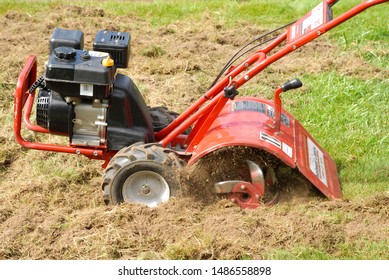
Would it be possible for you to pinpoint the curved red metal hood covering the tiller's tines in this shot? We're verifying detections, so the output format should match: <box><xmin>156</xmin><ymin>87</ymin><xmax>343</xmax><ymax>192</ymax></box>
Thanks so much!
<box><xmin>188</xmin><ymin>97</ymin><xmax>342</xmax><ymax>199</ymax></box>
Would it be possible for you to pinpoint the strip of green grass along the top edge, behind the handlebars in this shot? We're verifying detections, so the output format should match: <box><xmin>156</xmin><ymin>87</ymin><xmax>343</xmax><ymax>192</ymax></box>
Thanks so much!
<box><xmin>0</xmin><ymin>0</ymin><xmax>389</xmax><ymax>65</ymax></box>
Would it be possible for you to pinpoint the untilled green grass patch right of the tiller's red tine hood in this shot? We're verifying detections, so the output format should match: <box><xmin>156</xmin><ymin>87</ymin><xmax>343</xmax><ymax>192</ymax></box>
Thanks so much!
<box><xmin>288</xmin><ymin>72</ymin><xmax>389</xmax><ymax>198</ymax></box>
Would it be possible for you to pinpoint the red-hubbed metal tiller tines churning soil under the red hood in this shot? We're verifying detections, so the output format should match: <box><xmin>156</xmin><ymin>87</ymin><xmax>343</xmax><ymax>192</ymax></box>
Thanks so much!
<box><xmin>214</xmin><ymin>160</ymin><xmax>270</xmax><ymax>208</ymax></box>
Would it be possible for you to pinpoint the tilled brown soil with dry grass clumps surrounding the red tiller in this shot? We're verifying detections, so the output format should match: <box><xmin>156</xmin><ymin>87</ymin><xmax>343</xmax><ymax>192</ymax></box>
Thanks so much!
<box><xmin>0</xmin><ymin>6</ymin><xmax>389</xmax><ymax>259</ymax></box>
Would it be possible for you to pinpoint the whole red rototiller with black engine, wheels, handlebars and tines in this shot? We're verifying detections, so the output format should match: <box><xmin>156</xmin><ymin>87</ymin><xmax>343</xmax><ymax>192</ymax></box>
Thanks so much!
<box><xmin>14</xmin><ymin>0</ymin><xmax>387</xmax><ymax>208</ymax></box>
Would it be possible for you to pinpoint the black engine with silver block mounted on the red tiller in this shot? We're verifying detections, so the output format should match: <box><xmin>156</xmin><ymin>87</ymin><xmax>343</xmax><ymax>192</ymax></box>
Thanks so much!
<box><xmin>36</xmin><ymin>29</ymin><xmax>155</xmax><ymax>151</ymax></box>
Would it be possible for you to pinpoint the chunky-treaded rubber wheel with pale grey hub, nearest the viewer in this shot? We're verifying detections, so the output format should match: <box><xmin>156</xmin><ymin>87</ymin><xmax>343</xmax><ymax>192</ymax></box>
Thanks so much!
<box><xmin>102</xmin><ymin>143</ymin><xmax>181</xmax><ymax>207</ymax></box>
